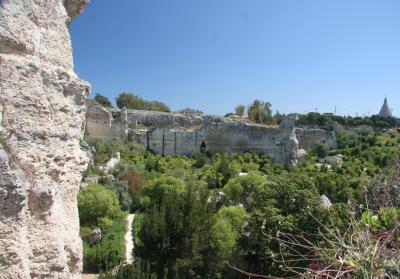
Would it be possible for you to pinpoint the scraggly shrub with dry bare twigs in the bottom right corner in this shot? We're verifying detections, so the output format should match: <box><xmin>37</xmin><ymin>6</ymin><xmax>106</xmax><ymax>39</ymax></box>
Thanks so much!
<box><xmin>278</xmin><ymin>208</ymin><xmax>400</xmax><ymax>278</ymax></box>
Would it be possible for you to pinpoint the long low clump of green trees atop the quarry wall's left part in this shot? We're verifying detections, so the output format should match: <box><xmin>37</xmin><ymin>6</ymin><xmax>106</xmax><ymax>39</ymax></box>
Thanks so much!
<box><xmin>116</xmin><ymin>93</ymin><xmax>171</xmax><ymax>112</ymax></box>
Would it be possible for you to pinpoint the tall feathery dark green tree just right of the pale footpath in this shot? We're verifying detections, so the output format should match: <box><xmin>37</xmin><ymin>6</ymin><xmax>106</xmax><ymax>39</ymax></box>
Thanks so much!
<box><xmin>136</xmin><ymin>178</ymin><xmax>235</xmax><ymax>278</ymax></box>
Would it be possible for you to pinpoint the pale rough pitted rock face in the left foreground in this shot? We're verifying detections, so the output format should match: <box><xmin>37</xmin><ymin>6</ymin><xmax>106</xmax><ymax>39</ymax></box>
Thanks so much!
<box><xmin>0</xmin><ymin>0</ymin><xmax>89</xmax><ymax>279</ymax></box>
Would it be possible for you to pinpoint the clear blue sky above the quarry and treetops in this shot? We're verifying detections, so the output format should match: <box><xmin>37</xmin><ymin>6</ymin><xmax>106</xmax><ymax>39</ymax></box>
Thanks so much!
<box><xmin>71</xmin><ymin>0</ymin><xmax>400</xmax><ymax>116</ymax></box>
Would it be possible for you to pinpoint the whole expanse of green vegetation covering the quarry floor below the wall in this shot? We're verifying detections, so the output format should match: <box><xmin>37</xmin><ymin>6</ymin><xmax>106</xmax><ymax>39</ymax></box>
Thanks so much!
<box><xmin>79</xmin><ymin>127</ymin><xmax>400</xmax><ymax>279</ymax></box>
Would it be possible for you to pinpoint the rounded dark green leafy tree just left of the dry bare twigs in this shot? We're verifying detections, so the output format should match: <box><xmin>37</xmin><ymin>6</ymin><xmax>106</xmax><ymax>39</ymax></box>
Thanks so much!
<box><xmin>237</xmin><ymin>174</ymin><xmax>325</xmax><ymax>275</ymax></box>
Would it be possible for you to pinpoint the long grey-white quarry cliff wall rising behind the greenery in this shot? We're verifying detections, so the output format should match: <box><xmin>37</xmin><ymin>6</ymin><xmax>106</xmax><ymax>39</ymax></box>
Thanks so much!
<box><xmin>86</xmin><ymin>100</ymin><xmax>336</xmax><ymax>166</ymax></box>
